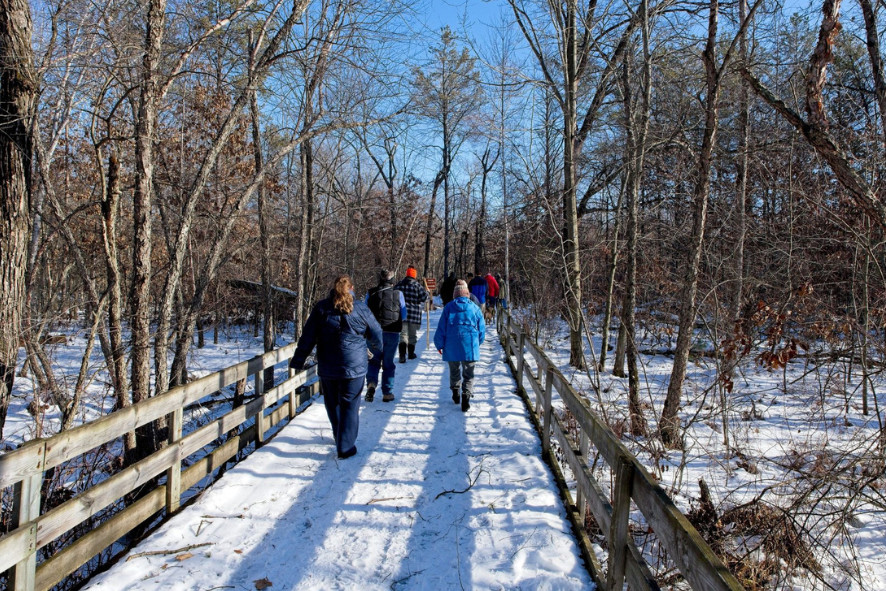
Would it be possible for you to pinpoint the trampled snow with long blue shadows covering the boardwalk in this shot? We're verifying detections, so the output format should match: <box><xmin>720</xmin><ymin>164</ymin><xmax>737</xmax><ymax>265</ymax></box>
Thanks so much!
<box><xmin>86</xmin><ymin>315</ymin><xmax>593</xmax><ymax>591</ymax></box>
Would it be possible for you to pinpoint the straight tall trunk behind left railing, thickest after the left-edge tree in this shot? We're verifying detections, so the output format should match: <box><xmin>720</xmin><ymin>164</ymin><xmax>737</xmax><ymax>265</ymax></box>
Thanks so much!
<box><xmin>128</xmin><ymin>0</ymin><xmax>166</xmax><ymax>462</ymax></box>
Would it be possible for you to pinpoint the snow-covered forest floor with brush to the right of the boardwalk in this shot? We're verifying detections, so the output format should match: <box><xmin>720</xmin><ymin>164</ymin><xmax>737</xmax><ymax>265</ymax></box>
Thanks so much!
<box><xmin>515</xmin><ymin>313</ymin><xmax>886</xmax><ymax>591</ymax></box>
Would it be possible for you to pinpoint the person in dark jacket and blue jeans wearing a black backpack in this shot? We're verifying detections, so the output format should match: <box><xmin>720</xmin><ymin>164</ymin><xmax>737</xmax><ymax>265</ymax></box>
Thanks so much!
<box><xmin>366</xmin><ymin>269</ymin><xmax>408</xmax><ymax>402</ymax></box>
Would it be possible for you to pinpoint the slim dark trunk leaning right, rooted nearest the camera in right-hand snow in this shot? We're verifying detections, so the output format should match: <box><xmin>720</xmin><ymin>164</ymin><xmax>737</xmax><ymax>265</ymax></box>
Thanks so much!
<box><xmin>659</xmin><ymin>0</ymin><xmax>720</xmax><ymax>448</ymax></box>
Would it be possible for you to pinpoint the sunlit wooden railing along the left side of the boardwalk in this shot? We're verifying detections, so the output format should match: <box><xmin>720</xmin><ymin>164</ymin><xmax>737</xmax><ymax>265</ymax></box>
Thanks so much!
<box><xmin>0</xmin><ymin>345</ymin><xmax>318</xmax><ymax>591</ymax></box>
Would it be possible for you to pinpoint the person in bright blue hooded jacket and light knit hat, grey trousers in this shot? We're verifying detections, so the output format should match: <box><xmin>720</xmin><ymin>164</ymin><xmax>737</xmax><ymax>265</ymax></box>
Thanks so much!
<box><xmin>434</xmin><ymin>279</ymin><xmax>486</xmax><ymax>412</ymax></box>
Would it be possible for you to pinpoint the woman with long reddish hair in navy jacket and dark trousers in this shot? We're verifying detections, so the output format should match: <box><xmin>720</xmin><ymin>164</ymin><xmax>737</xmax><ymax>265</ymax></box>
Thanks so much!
<box><xmin>289</xmin><ymin>275</ymin><xmax>382</xmax><ymax>458</ymax></box>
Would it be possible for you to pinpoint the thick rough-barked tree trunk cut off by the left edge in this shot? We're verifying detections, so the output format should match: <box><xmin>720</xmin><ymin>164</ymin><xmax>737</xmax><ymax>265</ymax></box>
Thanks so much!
<box><xmin>0</xmin><ymin>0</ymin><xmax>37</xmax><ymax>438</ymax></box>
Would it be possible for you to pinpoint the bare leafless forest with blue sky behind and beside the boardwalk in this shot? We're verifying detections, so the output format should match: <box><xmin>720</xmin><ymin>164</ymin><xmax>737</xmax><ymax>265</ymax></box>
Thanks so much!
<box><xmin>0</xmin><ymin>0</ymin><xmax>886</xmax><ymax>588</ymax></box>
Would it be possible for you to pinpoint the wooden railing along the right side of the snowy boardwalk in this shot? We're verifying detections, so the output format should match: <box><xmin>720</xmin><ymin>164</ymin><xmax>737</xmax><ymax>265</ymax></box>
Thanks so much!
<box><xmin>497</xmin><ymin>310</ymin><xmax>743</xmax><ymax>591</ymax></box>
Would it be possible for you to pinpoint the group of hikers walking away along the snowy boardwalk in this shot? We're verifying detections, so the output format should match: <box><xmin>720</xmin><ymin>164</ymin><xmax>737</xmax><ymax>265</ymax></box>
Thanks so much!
<box><xmin>289</xmin><ymin>266</ymin><xmax>499</xmax><ymax>459</ymax></box>
